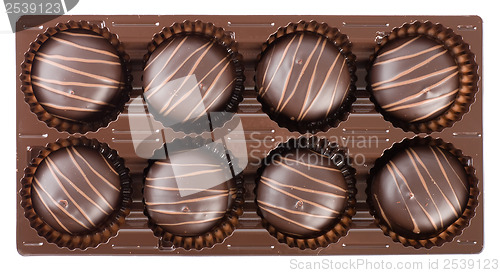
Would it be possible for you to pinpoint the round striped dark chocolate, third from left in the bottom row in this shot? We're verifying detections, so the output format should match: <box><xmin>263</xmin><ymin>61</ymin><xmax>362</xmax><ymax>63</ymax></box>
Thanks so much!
<box><xmin>256</xmin><ymin>148</ymin><xmax>348</xmax><ymax>238</ymax></box>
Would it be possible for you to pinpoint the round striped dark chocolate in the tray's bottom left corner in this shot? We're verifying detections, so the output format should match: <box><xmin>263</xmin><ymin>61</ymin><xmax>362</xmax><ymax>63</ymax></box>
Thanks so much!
<box><xmin>31</xmin><ymin>146</ymin><xmax>122</xmax><ymax>235</ymax></box>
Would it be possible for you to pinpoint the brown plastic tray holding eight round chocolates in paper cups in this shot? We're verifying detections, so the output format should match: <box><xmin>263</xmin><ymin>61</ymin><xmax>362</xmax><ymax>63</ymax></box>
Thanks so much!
<box><xmin>16</xmin><ymin>15</ymin><xmax>483</xmax><ymax>255</ymax></box>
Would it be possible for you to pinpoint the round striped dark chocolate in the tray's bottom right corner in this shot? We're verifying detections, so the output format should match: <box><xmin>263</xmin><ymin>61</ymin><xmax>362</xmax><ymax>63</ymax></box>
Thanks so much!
<box><xmin>368</xmin><ymin>145</ymin><xmax>469</xmax><ymax>239</ymax></box>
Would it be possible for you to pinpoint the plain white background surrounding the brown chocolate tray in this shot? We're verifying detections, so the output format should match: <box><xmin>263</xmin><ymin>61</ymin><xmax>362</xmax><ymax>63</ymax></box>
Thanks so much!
<box><xmin>0</xmin><ymin>0</ymin><xmax>500</xmax><ymax>273</ymax></box>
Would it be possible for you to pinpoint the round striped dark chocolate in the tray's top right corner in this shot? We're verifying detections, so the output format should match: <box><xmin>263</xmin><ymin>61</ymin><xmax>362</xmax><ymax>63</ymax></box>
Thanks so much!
<box><xmin>368</xmin><ymin>35</ymin><xmax>460</xmax><ymax>123</ymax></box>
